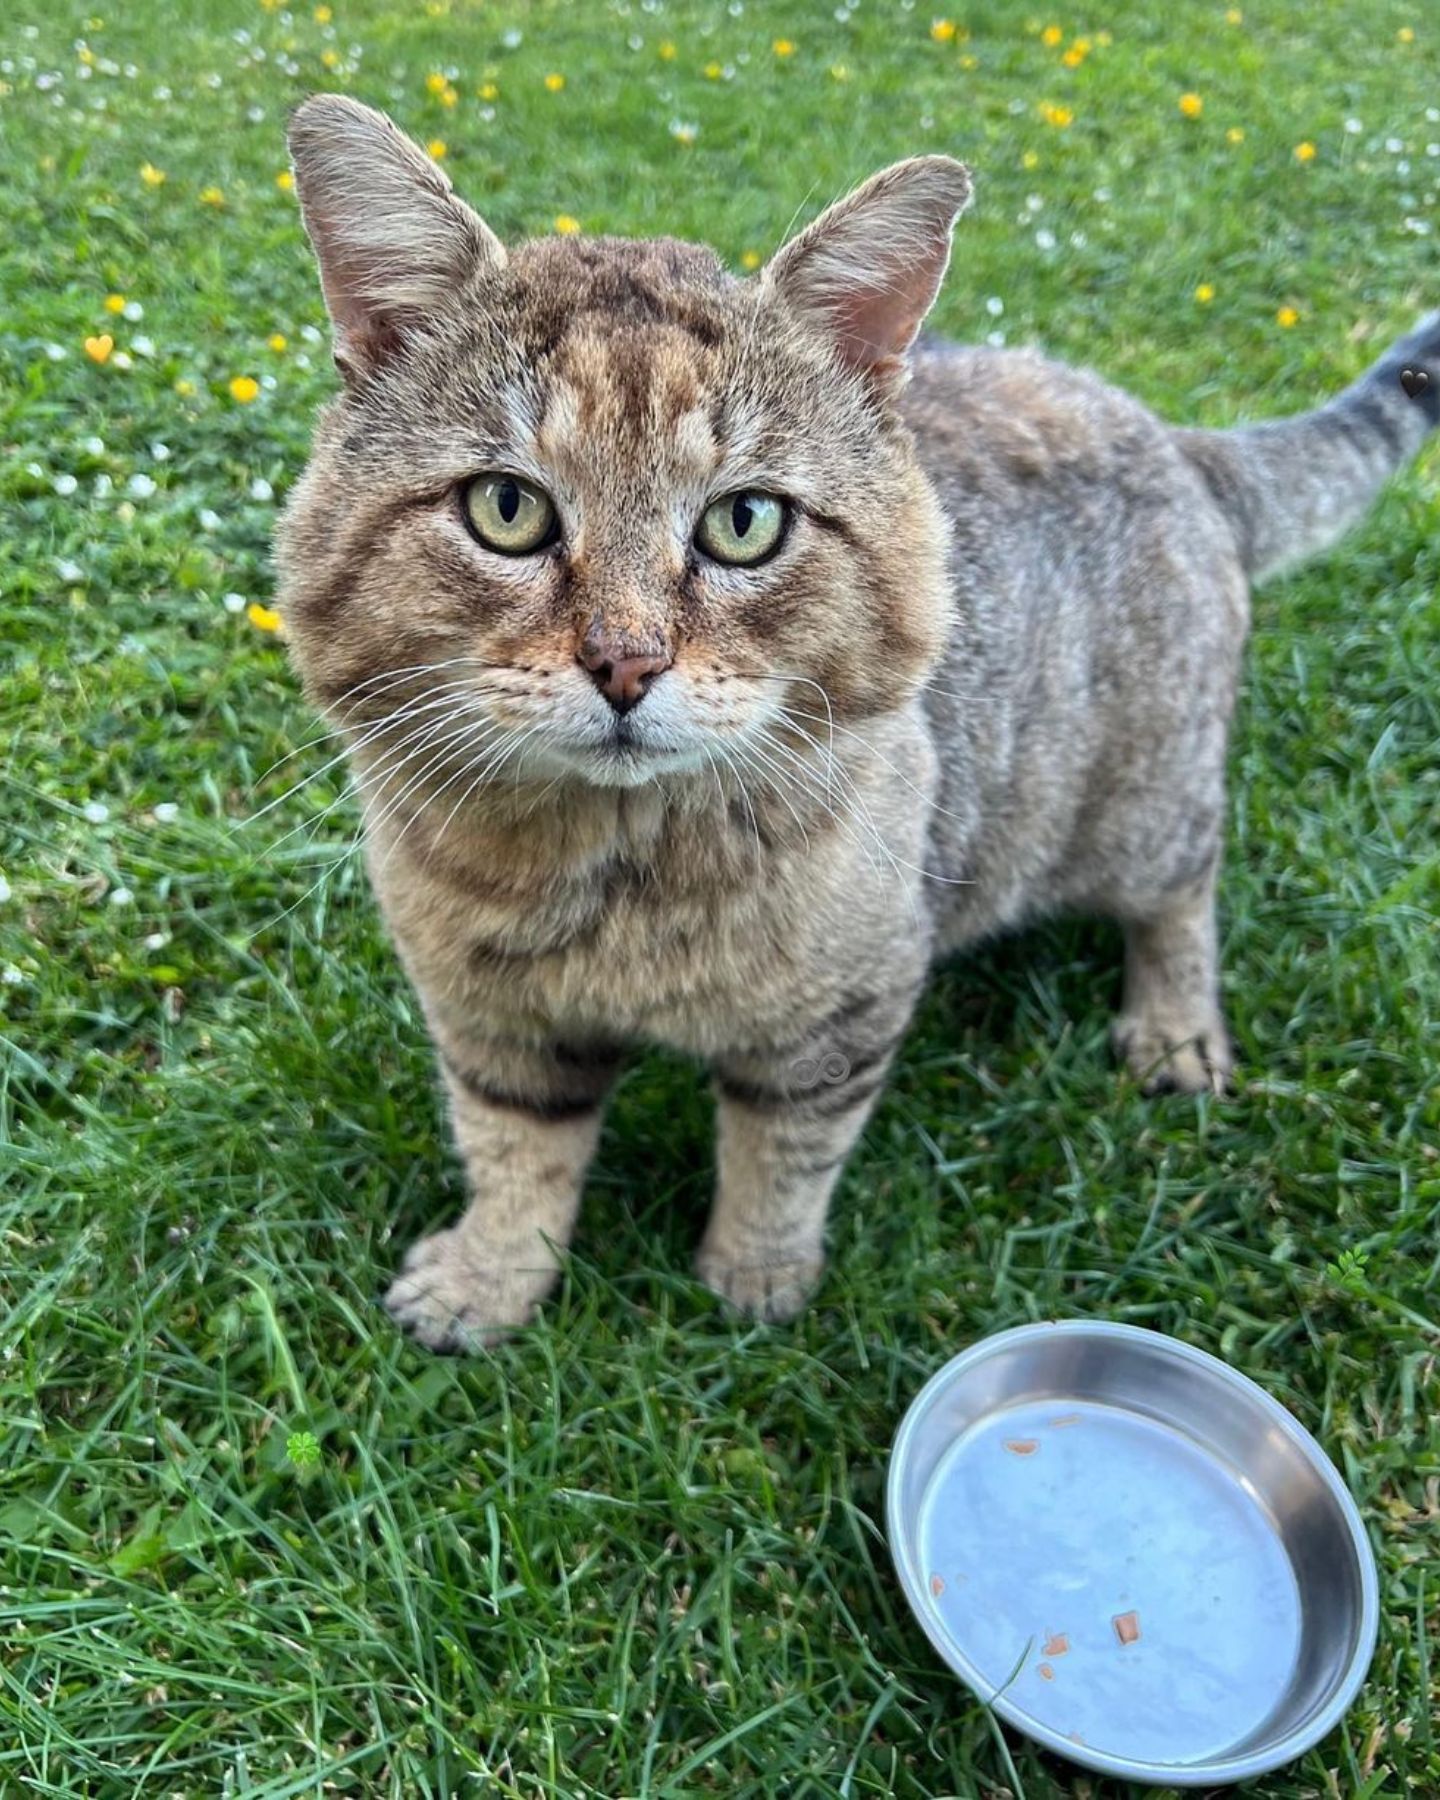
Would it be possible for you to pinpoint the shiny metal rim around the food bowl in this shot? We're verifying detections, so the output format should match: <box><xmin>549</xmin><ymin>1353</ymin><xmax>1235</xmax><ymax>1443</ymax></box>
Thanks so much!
<box><xmin>886</xmin><ymin>1319</ymin><xmax>1381</xmax><ymax>1787</ymax></box>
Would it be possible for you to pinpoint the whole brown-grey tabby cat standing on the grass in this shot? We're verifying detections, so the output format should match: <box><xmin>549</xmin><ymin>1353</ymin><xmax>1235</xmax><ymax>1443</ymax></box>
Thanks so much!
<box><xmin>279</xmin><ymin>95</ymin><xmax>1440</xmax><ymax>1348</ymax></box>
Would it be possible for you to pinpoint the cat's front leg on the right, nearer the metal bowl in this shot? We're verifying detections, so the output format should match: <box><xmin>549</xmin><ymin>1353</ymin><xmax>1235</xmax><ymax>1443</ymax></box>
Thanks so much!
<box><xmin>695</xmin><ymin>995</ymin><xmax>913</xmax><ymax>1321</ymax></box>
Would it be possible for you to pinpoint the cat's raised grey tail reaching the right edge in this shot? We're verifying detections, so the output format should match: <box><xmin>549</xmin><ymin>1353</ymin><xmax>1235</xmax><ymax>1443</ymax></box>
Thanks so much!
<box><xmin>1175</xmin><ymin>311</ymin><xmax>1440</xmax><ymax>580</ymax></box>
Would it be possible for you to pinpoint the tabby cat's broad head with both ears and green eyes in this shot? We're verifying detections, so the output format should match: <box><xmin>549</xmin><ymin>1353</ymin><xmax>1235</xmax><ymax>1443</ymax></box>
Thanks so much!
<box><xmin>279</xmin><ymin>95</ymin><xmax>970</xmax><ymax>787</ymax></box>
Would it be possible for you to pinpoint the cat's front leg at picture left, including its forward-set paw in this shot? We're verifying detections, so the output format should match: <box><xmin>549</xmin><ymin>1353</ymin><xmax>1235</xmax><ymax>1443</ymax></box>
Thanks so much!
<box><xmin>385</xmin><ymin>1033</ymin><xmax>619</xmax><ymax>1350</ymax></box>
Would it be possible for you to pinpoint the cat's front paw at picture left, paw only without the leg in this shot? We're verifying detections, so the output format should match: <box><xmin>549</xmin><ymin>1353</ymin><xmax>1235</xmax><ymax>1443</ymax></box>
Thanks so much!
<box><xmin>385</xmin><ymin>1228</ymin><xmax>556</xmax><ymax>1350</ymax></box>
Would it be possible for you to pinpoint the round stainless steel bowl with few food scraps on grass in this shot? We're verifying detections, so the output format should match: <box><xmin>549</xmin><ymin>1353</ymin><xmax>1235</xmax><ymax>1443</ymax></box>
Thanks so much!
<box><xmin>886</xmin><ymin>1319</ymin><xmax>1379</xmax><ymax>1787</ymax></box>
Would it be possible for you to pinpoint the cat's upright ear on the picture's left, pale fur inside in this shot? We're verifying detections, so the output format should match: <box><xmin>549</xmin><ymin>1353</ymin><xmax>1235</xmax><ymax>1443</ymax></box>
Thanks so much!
<box><xmin>288</xmin><ymin>94</ymin><xmax>506</xmax><ymax>380</ymax></box>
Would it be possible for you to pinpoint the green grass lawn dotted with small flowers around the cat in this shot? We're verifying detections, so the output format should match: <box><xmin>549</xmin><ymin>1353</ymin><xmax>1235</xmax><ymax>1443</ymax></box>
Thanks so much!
<box><xmin>0</xmin><ymin>0</ymin><xmax>1440</xmax><ymax>1800</ymax></box>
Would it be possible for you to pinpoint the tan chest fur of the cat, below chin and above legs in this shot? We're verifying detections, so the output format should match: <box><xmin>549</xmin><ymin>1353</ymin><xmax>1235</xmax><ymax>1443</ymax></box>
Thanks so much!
<box><xmin>358</xmin><ymin>770</ymin><xmax>929</xmax><ymax>1055</ymax></box>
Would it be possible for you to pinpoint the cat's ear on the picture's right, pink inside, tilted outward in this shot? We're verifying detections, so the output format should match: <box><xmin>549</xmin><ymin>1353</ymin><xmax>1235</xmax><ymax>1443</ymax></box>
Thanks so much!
<box><xmin>760</xmin><ymin>157</ymin><xmax>970</xmax><ymax>391</ymax></box>
